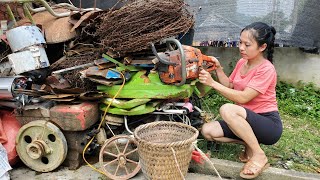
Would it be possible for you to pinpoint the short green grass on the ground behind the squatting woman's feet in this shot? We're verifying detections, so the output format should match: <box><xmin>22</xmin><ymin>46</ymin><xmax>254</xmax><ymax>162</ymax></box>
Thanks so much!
<box><xmin>262</xmin><ymin>113</ymin><xmax>320</xmax><ymax>172</ymax></box>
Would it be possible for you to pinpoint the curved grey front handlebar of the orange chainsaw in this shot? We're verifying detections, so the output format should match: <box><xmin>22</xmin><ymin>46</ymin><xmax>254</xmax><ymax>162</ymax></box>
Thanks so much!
<box><xmin>165</xmin><ymin>39</ymin><xmax>187</xmax><ymax>86</ymax></box>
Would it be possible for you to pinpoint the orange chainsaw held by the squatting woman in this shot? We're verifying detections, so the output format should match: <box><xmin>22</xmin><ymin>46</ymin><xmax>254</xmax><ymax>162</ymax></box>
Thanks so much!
<box><xmin>151</xmin><ymin>39</ymin><xmax>217</xmax><ymax>86</ymax></box>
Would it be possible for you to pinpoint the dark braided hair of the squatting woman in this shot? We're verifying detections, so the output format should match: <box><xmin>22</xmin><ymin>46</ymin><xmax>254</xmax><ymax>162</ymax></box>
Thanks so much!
<box><xmin>241</xmin><ymin>22</ymin><xmax>277</xmax><ymax>63</ymax></box>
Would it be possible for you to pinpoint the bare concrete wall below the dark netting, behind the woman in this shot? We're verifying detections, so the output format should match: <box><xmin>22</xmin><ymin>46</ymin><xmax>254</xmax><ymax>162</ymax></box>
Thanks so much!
<box><xmin>198</xmin><ymin>46</ymin><xmax>320</xmax><ymax>88</ymax></box>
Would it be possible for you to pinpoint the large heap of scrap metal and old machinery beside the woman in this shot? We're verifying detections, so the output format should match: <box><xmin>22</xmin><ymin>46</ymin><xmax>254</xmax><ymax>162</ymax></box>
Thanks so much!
<box><xmin>0</xmin><ymin>0</ymin><xmax>215</xmax><ymax>178</ymax></box>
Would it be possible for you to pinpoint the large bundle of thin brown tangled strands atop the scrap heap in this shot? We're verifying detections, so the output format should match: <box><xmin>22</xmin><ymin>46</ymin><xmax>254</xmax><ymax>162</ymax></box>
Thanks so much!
<box><xmin>85</xmin><ymin>0</ymin><xmax>194</xmax><ymax>56</ymax></box>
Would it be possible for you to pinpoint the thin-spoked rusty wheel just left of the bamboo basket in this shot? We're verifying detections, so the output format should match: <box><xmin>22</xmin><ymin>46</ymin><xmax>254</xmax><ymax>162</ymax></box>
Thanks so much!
<box><xmin>99</xmin><ymin>135</ymin><xmax>141</xmax><ymax>179</ymax></box>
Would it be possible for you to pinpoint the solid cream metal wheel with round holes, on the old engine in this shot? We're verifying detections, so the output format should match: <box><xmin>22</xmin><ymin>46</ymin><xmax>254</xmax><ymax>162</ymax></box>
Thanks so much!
<box><xmin>16</xmin><ymin>120</ymin><xmax>68</xmax><ymax>172</ymax></box>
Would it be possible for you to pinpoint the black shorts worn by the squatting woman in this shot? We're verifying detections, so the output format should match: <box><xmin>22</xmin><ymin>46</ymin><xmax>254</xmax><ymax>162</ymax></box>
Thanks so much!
<box><xmin>218</xmin><ymin>108</ymin><xmax>282</xmax><ymax>145</ymax></box>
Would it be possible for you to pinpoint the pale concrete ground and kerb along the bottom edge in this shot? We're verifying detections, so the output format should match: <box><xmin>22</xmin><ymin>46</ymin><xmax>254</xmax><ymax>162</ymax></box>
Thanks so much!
<box><xmin>10</xmin><ymin>158</ymin><xmax>320</xmax><ymax>180</ymax></box>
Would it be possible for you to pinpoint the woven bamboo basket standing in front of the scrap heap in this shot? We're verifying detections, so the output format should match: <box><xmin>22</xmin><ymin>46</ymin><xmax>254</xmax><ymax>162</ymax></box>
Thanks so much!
<box><xmin>134</xmin><ymin>121</ymin><xmax>199</xmax><ymax>179</ymax></box>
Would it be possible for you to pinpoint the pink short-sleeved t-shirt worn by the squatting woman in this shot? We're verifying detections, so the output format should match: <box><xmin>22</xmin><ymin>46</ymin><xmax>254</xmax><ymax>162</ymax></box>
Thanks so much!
<box><xmin>229</xmin><ymin>58</ymin><xmax>278</xmax><ymax>113</ymax></box>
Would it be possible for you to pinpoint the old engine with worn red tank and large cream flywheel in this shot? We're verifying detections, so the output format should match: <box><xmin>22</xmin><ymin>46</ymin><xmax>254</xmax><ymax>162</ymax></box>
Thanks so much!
<box><xmin>14</xmin><ymin>101</ymin><xmax>100</xmax><ymax>172</ymax></box>
